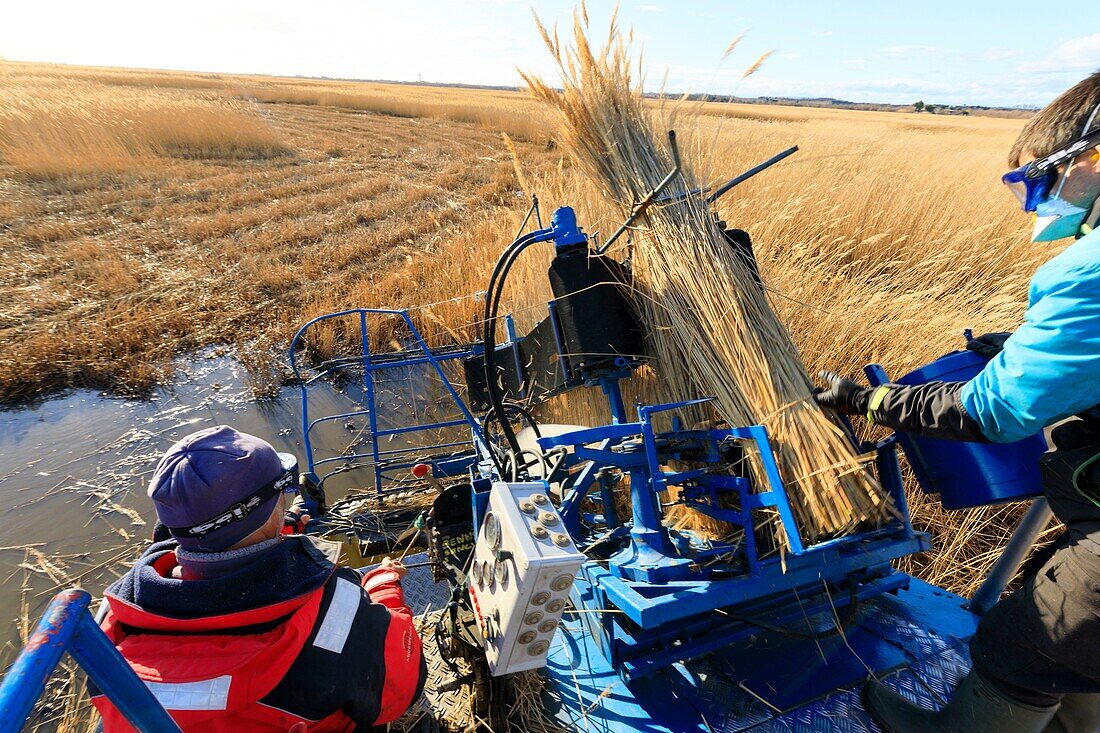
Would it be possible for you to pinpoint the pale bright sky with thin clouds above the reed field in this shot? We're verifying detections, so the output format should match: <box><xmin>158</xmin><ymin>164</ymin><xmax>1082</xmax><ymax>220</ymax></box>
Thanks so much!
<box><xmin>0</xmin><ymin>0</ymin><xmax>1100</xmax><ymax>106</ymax></box>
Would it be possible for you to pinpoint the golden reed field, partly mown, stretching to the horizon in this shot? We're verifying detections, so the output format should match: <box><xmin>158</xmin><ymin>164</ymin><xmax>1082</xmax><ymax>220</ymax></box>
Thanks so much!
<box><xmin>0</xmin><ymin>63</ymin><xmax>1054</xmax><ymax>593</ymax></box>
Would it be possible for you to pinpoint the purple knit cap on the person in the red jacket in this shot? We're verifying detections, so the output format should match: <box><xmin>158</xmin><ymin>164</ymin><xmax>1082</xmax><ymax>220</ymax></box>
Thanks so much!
<box><xmin>149</xmin><ymin>425</ymin><xmax>285</xmax><ymax>553</ymax></box>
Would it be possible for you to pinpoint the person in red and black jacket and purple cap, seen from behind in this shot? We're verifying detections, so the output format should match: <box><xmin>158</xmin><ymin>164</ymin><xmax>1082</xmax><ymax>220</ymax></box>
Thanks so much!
<box><xmin>91</xmin><ymin>426</ymin><xmax>427</xmax><ymax>733</ymax></box>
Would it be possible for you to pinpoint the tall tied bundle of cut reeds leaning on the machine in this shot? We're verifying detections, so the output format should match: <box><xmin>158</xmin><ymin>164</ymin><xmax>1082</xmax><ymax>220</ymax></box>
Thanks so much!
<box><xmin>525</xmin><ymin>6</ymin><xmax>890</xmax><ymax>540</ymax></box>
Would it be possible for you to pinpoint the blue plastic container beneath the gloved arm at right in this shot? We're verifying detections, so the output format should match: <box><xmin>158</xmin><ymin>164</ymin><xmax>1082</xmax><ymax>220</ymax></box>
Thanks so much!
<box><xmin>867</xmin><ymin>351</ymin><xmax>1046</xmax><ymax>510</ymax></box>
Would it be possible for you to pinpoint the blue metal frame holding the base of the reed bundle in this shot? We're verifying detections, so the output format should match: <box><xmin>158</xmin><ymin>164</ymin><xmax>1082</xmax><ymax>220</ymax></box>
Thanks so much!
<box><xmin>539</xmin><ymin>375</ymin><xmax>931</xmax><ymax>680</ymax></box>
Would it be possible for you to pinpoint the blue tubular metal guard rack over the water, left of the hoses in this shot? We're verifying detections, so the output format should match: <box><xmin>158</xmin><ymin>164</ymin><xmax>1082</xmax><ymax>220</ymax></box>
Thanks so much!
<box><xmin>289</xmin><ymin>308</ymin><xmax>486</xmax><ymax>494</ymax></box>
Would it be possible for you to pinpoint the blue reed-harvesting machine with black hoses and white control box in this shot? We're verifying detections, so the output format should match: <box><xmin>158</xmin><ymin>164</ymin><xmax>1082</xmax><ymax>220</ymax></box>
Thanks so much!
<box><xmin>0</xmin><ymin>145</ymin><xmax>1049</xmax><ymax>733</ymax></box>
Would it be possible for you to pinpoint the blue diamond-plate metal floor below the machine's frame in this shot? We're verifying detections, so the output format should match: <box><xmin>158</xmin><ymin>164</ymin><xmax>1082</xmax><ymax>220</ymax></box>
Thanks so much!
<box><xmin>546</xmin><ymin>580</ymin><xmax>977</xmax><ymax>733</ymax></box>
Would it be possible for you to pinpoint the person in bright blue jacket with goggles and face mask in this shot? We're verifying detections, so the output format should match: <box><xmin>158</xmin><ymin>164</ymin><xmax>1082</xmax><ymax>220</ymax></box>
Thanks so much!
<box><xmin>815</xmin><ymin>72</ymin><xmax>1100</xmax><ymax>733</ymax></box>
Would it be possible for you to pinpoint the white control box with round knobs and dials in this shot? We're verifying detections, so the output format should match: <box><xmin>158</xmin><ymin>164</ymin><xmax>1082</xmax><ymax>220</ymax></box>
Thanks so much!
<box><xmin>468</xmin><ymin>481</ymin><xmax>584</xmax><ymax>676</ymax></box>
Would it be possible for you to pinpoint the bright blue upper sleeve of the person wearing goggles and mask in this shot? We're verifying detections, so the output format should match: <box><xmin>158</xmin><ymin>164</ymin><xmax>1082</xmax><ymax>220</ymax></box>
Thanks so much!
<box><xmin>961</xmin><ymin>265</ymin><xmax>1100</xmax><ymax>442</ymax></box>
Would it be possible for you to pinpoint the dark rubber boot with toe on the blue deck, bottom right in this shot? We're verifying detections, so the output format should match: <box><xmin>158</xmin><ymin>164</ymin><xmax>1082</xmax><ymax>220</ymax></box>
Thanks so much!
<box><xmin>864</xmin><ymin>671</ymin><xmax>1057</xmax><ymax>733</ymax></box>
